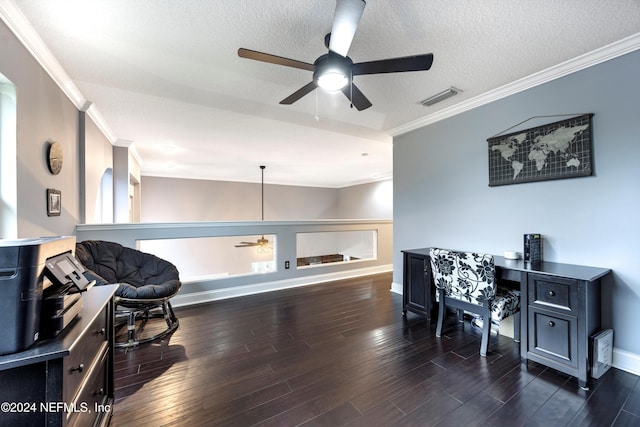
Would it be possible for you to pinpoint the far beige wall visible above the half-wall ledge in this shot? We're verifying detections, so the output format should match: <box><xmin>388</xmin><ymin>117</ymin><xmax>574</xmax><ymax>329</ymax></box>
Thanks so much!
<box><xmin>140</xmin><ymin>176</ymin><xmax>393</xmax><ymax>222</ymax></box>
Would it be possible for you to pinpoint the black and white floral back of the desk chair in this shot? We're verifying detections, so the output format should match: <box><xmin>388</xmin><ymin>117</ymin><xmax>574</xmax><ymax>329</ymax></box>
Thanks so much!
<box><xmin>429</xmin><ymin>248</ymin><xmax>496</xmax><ymax>306</ymax></box>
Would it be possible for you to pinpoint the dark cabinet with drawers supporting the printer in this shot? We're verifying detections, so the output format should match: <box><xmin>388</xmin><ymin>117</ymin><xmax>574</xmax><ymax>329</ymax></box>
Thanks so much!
<box><xmin>0</xmin><ymin>285</ymin><xmax>117</xmax><ymax>426</ymax></box>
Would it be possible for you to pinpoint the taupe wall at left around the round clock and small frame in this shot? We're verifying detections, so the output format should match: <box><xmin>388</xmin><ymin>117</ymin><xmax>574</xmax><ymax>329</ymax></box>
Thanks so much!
<box><xmin>0</xmin><ymin>22</ymin><xmax>79</xmax><ymax>237</ymax></box>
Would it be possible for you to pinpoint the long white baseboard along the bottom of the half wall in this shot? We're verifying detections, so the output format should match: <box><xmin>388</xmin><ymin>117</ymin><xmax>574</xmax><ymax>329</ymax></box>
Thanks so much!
<box><xmin>171</xmin><ymin>264</ymin><xmax>393</xmax><ymax>307</ymax></box>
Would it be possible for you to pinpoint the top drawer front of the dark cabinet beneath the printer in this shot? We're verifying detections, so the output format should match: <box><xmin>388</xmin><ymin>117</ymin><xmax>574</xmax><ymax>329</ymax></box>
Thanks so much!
<box><xmin>62</xmin><ymin>309</ymin><xmax>108</xmax><ymax>402</ymax></box>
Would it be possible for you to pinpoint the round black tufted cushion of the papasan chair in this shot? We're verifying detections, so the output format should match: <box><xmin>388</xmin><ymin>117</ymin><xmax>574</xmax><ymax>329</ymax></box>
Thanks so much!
<box><xmin>76</xmin><ymin>240</ymin><xmax>182</xmax><ymax>299</ymax></box>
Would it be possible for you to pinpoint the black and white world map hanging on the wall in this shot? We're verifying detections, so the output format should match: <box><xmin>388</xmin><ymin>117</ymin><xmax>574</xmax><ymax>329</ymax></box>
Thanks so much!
<box><xmin>487</xmin><ymin>114</ymin><xmax>593</xmax><ymax>187</ymax></box>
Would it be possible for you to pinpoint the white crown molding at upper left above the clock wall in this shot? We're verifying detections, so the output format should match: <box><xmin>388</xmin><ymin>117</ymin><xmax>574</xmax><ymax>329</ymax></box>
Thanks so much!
<box><xmin>0</xmin><ymin>0</ymin><xmax>118</xmax><ymax>144</ymax></box>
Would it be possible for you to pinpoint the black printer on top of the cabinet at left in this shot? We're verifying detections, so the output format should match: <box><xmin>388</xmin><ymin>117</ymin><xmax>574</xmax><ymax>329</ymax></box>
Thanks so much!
<box><xmin>0</xmin><ymin>236</ymin><xmax>94</xmax><ymax>355</ymax></box>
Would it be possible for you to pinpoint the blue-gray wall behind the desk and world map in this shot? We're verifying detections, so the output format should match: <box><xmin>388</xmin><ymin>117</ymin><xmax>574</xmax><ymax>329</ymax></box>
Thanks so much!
<box><xmin>393</xmin><ymin>51</ymin><xmax>640</xmax><ymax>355</ymax></box>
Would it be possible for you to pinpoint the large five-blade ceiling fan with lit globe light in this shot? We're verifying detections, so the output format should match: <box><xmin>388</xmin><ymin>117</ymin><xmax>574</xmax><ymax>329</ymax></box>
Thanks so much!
<box><xmin>238</xmin><ymin>0</ymin><xmax>433</xmax><ymax>111</ymax></box>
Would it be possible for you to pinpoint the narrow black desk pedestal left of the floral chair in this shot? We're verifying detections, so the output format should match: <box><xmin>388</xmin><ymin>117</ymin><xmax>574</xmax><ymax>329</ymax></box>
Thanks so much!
<box><xmin>402</xmin><ymin>249</ymin><xmax>434</xmax><ymax>320</ymax></box>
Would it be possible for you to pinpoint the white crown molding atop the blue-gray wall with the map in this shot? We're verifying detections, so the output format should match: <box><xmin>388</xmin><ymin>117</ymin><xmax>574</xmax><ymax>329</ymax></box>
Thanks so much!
<box><xmin>388</xmin><ymin>33</ymin><xmax>640</xmax><ymax>136</ymax></box>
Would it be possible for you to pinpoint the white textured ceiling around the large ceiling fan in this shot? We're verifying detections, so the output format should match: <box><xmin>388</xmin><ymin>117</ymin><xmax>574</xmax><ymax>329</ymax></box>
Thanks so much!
<box><xmin>0</xmin><ymin>0</ymin><xmax>640</xmax><ymax>187</ymax></box>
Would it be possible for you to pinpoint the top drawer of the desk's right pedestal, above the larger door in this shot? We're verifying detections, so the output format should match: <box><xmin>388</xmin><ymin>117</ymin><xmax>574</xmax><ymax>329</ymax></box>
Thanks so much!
<box><xmin>528</xmin><ymin>274</ymin><xmax>578</xmax><ymax>311</ymax></box>
